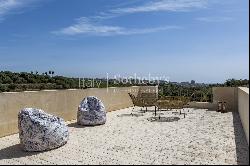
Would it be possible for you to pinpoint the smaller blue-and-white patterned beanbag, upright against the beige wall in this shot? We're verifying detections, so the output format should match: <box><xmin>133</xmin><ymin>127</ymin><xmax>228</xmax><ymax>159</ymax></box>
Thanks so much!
<box><xmin>77</xmin><ymin>96</ymin><xmax>106</xmax><ymax>126</ymax></box>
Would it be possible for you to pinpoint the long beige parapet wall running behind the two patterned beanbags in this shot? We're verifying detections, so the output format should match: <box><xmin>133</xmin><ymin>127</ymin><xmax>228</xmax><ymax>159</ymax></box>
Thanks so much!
<box><xmin>0</xmin><ymin>87</ymin><xmax>139</xmax><ymax>137</ymax></box>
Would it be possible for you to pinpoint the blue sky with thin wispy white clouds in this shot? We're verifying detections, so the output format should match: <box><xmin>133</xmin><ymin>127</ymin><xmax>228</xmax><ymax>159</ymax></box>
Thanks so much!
<box><xmin>0</xmin><ymin>0</ymin><xmax>249</xmax><ymax>83</ymax></box>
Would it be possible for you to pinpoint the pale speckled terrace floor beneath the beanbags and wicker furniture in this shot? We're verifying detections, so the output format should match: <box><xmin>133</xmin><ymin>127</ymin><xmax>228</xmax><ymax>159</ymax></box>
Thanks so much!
<box><xmin>0</xmin><ymin>108</ymin><xmax>249</xmax><ymax>165</ymax></box>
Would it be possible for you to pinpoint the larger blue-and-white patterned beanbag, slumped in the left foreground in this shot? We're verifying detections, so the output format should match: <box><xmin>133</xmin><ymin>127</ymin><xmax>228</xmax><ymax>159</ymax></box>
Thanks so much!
<box><xmin>18</xmin><ymin>108</ymin><xmax>69</xmax><ymax>152</ymax></box>
